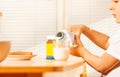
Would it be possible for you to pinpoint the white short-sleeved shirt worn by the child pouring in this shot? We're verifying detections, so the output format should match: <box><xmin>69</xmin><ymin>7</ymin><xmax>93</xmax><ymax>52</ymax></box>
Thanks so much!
<box><xmin>105</xmin><ymin>30</ymin><xmax>120</xmax><ymax>77</ymax></box>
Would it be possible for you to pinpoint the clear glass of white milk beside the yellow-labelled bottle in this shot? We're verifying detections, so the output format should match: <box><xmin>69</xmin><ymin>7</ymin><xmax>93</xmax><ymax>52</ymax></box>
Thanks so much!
<box><xmin>54</xmin><ymin>47</ymin><xmax>69</xmax><ymax>61</ymax></box>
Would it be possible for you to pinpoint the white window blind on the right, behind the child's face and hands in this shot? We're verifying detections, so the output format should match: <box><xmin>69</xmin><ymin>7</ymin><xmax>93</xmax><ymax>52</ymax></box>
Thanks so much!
<box><xmin>67</xmin><ymin>0</ymin><xmax>110</xmax><ymax>25</ymax></box>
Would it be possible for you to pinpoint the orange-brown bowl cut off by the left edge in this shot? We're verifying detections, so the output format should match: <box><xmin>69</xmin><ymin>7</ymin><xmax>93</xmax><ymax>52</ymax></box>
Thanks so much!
<box><xmin>0</xmin><ymin>41</ymin><xmax>11</xmax><ymax>62</ymax></box>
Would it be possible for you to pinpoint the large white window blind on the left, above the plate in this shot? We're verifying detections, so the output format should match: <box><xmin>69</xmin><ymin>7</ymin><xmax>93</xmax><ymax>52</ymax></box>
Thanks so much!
<box><xmin>0</xmin><ymin>0</ymin><xmax>57</xmax><ymax>51</ymax></box>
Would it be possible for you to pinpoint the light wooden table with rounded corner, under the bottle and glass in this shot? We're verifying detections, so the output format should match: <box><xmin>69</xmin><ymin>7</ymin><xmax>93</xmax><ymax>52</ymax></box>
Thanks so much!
<box><xmin>0</xmin><ymin>57</ymin><xmax>84</xmax><ymax>77</ymax></box>
